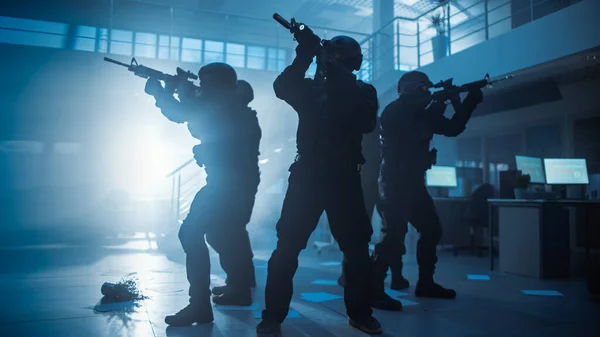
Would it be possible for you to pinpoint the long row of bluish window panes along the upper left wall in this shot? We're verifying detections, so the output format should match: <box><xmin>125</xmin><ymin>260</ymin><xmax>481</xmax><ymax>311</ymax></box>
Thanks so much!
<box><xmin>0</xmin><ymin>16</ymin><xmax>294</xmax><ymax>74</ymax></box>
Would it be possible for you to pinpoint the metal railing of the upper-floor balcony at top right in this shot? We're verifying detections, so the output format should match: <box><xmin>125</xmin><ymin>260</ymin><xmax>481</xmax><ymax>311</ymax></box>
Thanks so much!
<box><xmin>360</xmin><ymin>0</ymin><xmax>582</xmax><ymax>81</ymax></box>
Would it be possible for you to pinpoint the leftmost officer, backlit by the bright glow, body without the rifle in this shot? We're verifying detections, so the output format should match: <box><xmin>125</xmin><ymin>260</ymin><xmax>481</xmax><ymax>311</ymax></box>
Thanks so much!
<box><xmin>146</xmin><ymin>63</ymin><xmax>261</xmax><ymax>326</ymax></box>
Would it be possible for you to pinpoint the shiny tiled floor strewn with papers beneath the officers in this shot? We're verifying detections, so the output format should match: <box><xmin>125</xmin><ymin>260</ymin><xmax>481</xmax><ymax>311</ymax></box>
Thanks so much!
<box><xmin>0</xmin><ymin>236</ymin><xmax>600</xmax><ymax>337</ymax></box>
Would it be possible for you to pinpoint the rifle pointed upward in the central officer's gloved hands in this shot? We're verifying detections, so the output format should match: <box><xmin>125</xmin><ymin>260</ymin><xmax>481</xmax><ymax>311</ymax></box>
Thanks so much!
<box><xmin>273</xmin><ymin>13</ymin><xmax>355</xmax><ymax>81</ymax></box>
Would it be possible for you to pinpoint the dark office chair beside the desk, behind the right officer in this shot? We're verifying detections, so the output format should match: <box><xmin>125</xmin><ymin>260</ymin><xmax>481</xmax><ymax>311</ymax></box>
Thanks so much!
<box><xmin>453</xmin><ymin>184</ymin><xmax>496</xmax><ymax>257</ymax></box>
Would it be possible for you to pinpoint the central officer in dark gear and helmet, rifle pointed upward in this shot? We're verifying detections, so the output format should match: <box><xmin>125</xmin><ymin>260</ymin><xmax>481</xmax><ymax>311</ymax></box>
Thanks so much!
<box><xmin>256</xmin><ymin>14</ymin><xmax>382</xmax><ymax>337</ymax></box>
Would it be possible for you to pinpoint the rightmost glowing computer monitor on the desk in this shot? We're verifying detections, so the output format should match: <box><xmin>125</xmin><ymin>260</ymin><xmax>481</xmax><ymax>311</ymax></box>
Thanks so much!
<box><xmin>544</xmin><ymin>158</ymin><xmax>590</xmax><ymax>185</ymax></box>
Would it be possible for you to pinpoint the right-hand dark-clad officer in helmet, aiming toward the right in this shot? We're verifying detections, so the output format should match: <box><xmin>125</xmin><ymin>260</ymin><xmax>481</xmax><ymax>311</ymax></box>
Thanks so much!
<box><xmin>373</xmin><ymin>71</ymin><xmax>484</xmax><ymax>298</ymax></box>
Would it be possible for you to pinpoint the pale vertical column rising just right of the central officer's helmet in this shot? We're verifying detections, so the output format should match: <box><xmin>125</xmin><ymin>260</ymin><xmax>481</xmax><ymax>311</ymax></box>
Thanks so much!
<box><xmin>370</xmin><ymin>0</ymin><xmax>394</xmax><ymax>80</ymax></box>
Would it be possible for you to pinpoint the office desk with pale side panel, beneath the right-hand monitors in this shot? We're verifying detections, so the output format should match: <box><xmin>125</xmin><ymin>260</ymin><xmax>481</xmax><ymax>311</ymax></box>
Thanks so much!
<box><xmin>488</xmin><ymin>199</ymin><xmax>600</xmax><ymax>278</ymax></box>
